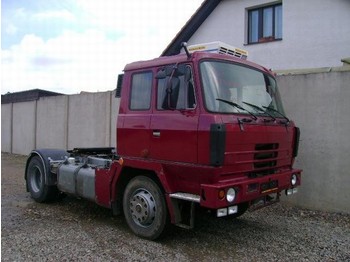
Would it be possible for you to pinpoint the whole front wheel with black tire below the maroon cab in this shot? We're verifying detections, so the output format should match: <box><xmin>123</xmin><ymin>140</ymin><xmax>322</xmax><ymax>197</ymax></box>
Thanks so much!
<box><xmin>123</xmin><ymin>176</ymin><xmax>169</xmax><ymax>240</ymax></box>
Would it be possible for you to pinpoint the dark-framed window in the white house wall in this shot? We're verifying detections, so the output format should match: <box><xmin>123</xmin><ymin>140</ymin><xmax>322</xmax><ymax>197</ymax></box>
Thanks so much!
<box><xmin>248</xmin><ymin>4</ymin><xmax>282</xmax><ymax>44</ymax></box>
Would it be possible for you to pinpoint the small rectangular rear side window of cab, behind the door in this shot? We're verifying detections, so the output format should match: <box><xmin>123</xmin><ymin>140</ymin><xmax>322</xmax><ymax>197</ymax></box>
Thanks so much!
<box><xmin>130</xmin><ymin>72</ymin><xmax>152</xmax><ymax>110</ymax></box>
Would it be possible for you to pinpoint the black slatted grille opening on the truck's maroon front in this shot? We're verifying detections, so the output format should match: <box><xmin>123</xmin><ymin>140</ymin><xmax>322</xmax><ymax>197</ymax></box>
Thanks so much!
<box><xmin>254</xmin><ymin>143</ymin><xmax>278</xmax><ymax>169</ymax></box>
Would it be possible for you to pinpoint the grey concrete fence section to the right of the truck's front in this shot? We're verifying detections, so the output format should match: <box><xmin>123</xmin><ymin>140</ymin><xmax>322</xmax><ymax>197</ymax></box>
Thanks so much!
<box><xmin>278</xmin><ymin>71</ymin><xmax>350</xmax><ymax>213</ymax></box>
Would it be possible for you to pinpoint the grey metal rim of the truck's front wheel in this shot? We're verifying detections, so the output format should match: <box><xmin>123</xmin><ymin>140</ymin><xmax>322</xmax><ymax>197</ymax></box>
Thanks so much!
<box><xmin>130</xmin><ymin>189</ymin><xmax>156</xmax><ymax>227</ymax></box>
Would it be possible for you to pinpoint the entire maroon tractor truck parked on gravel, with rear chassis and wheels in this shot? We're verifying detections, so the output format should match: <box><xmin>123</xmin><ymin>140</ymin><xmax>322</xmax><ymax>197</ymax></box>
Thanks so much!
<box><xmin>25</xmin><ymin>43</ymin><xmax>301</xmax><ymax>240</ymax></box>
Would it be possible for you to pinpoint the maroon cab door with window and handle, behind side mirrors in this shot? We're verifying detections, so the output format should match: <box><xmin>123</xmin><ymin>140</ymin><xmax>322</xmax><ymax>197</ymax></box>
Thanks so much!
<box><xmin>150</xmin><ymin>64</ymin><xmax>198</xmax><ymax>163</ymax></box>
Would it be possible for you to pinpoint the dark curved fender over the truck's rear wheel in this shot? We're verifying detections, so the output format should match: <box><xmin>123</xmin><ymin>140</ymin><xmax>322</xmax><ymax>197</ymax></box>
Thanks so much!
<box><xmin>24</xmin><ymin>149</ymin><xmax>70</xmax><ymax>191</ymax></box>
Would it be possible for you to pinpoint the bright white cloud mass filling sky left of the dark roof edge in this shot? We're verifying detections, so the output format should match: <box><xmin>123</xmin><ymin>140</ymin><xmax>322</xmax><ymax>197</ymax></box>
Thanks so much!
<box><xmin>1</xmin><ymin>0</ymin><xmax>202</xmax><ymax>94</ymax></box>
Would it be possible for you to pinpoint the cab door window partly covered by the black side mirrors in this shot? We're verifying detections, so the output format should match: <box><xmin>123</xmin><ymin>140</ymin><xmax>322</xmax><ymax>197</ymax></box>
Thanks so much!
<box><xmin>157</xmin><ymin>66</ymin><xmax>196</xmax><ymax>110</ymax></box>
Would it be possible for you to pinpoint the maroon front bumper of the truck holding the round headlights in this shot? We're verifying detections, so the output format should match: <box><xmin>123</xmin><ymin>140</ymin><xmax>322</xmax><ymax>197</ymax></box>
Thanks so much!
<box><xmin>200</xmin><ymin>169</ymin><xmax>301</xmax><ymax>209</ymax></box>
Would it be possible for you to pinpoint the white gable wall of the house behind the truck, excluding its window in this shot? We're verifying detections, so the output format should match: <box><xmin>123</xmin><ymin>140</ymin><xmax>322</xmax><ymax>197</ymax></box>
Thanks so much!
<box><xmin>188</xmin><ymin>0</ymin><xmax>350</xmax><ymax>70</ymax></box>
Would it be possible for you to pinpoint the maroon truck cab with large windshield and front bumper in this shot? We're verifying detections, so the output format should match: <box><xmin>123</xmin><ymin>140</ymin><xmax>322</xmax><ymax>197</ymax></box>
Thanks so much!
<box><xmin>117</xmin><ymin>42</ymin><xmax>300</xmax><ymax>206</ymax></box>
